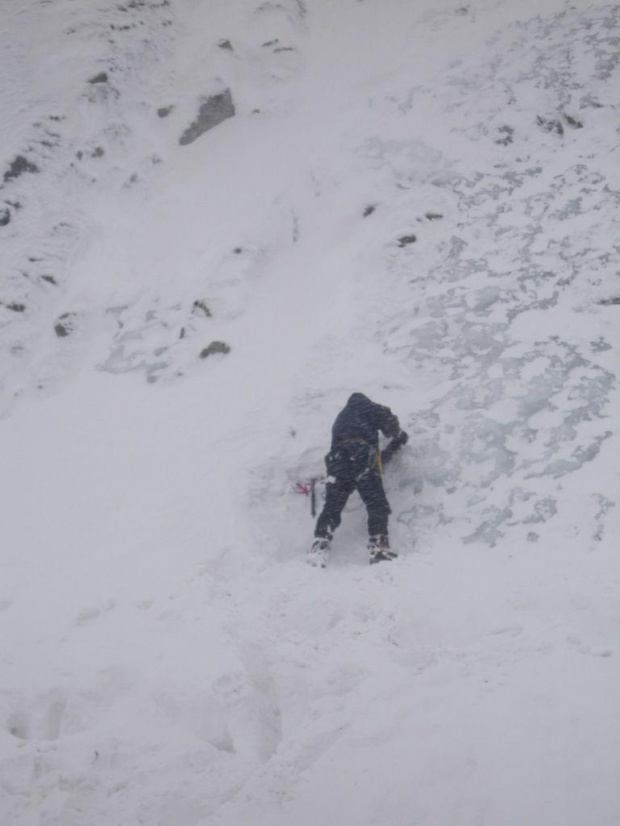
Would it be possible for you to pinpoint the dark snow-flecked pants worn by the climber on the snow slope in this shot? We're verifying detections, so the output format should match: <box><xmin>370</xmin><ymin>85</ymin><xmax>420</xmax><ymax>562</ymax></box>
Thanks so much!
<box><xmin>314</xmin><ymin>441</ymin><xmax>391</xmax><ymax>539</ymax></box>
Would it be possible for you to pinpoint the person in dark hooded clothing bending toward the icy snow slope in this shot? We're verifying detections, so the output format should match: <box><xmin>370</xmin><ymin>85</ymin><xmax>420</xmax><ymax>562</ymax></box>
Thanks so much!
<box><xmin>308</xmin><ymin>393</ymin><xmax>409</xmax><ymax>568</ymax></box>
